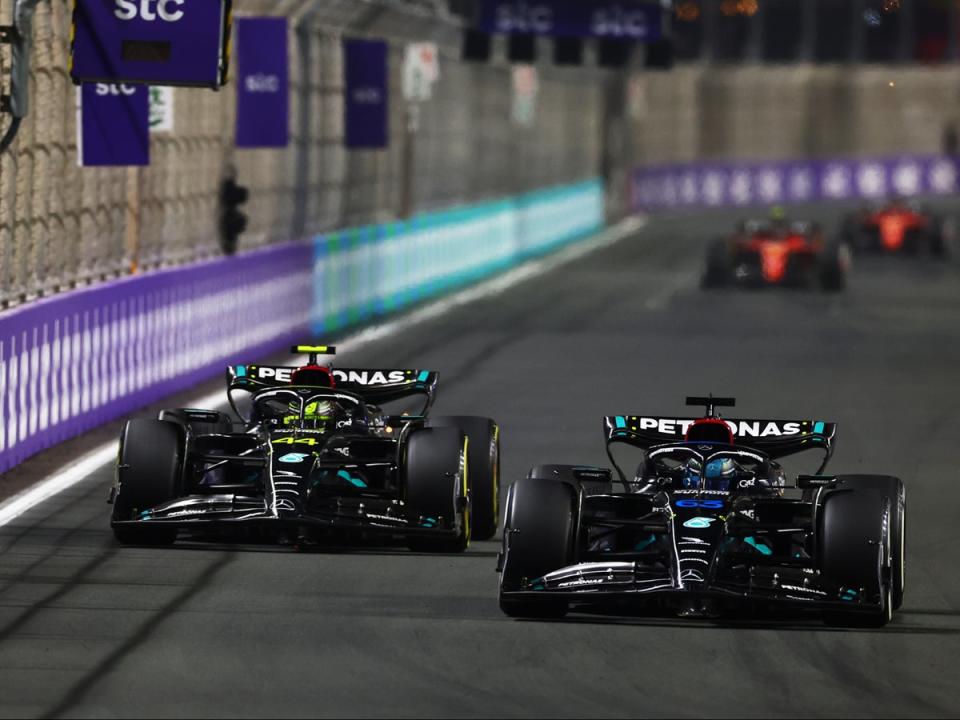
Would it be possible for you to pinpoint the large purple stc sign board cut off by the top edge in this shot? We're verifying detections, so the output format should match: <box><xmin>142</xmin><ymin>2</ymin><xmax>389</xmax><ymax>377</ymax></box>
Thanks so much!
<box><xmin>70</xmin><ymin>0</ymin><xmax>230</xmax><ymax>87</ymax></box>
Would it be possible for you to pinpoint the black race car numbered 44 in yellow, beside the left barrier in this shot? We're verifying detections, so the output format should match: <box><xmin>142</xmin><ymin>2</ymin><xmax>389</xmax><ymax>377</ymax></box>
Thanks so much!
<box><xmin>111</xmin><ymin>346</ymin><xmax>500</xmax><ymax>552</ymax></box>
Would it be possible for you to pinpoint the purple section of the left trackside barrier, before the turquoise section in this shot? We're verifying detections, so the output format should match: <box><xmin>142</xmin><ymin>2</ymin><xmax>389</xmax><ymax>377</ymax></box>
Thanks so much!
<box><xmin>0</xmin><ymin>242</ymin><xmax>313</xmax><ymax>472</ymax></box>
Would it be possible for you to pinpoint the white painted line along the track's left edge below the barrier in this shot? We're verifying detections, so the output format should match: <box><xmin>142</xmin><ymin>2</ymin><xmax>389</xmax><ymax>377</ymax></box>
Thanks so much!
<box><xmin>0</xmin><ymin>217</ymin><xmax>646</xmax><ymax>527</ymax></box>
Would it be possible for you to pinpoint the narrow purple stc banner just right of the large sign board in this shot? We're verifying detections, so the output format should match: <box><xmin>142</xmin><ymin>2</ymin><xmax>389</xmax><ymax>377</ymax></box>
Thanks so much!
<box><xmin>237</xmin><ymin>18</ymin><xmax>290</xmax><ymax>148</ymax></box>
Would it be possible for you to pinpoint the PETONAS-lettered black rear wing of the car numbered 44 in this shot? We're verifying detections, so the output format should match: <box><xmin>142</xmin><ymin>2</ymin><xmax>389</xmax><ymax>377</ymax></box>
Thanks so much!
<box><xmin>227</xmin><ymin>365</ymin><xmax>440</xmax><ymax>414</ymax></box>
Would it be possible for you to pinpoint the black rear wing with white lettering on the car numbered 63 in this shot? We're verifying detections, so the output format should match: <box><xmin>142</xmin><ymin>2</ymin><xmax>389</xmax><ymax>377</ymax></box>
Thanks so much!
<box><xmin>604</xmin><ymin>415</ymin><xmax>837</xmax><ymax>474</ymax></box>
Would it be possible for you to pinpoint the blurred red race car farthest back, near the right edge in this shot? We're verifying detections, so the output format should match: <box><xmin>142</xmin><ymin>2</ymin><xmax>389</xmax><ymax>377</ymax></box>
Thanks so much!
<box><xmin>843</xmin><ymin>199</ymin><xmax>947</xmax><ymax>257</ymax></box>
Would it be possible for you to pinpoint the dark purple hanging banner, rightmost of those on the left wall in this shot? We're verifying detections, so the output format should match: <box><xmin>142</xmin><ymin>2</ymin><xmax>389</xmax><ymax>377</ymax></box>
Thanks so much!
<box><xmin>343</xmin><ymin>39</ymin><xmax>390</xmax><ymax>150</ymax></box>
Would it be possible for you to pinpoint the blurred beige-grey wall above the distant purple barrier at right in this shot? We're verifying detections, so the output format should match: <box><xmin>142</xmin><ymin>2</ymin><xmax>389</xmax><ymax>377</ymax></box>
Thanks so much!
<box><xmin>631</xmin><ymin>65</ymin><xmax>960</xmax><ymax>165</ymax></box>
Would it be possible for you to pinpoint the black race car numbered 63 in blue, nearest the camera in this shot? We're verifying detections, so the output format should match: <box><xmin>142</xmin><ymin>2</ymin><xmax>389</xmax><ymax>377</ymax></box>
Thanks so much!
<box><xmin>499</xmin><ymin>398</ymin><xmax>905</xmax><ymax>626</ymax></box>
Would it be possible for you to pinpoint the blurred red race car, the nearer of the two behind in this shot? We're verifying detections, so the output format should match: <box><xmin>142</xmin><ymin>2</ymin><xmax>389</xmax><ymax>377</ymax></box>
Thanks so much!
<box><xmin>701</xmin><ymin>214</ymin><xmax>850</xmax><ymax>291</ymax></box>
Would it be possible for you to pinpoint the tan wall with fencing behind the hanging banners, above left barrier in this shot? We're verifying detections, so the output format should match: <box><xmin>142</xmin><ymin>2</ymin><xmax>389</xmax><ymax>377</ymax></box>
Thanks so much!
<box><xmin>0</xmin><ymin>0</ymin><xmax>611</xmax><ymax>308</ymax></box>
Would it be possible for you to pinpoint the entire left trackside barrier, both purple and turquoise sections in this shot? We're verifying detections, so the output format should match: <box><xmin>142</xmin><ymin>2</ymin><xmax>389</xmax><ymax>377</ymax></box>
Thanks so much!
<box><xmin>0</xmin><ymin>181</ymin><xmax>604</xmax><ymax>472</ymax></box>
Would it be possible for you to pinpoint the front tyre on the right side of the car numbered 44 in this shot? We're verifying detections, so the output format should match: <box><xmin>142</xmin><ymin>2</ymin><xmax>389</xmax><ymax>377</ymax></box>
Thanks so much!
<box><xmin>403</xmin><ymin>427</ymin><xmax>471</xmax><ymax>553</ymax></box>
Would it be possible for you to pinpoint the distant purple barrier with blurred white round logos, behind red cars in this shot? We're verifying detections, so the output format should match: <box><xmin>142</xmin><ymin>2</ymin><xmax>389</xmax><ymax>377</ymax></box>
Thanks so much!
<box><xmin>632</xmin><ymin>155</ymin><xmax>960</xmax><ymax>212</ymax></box>
